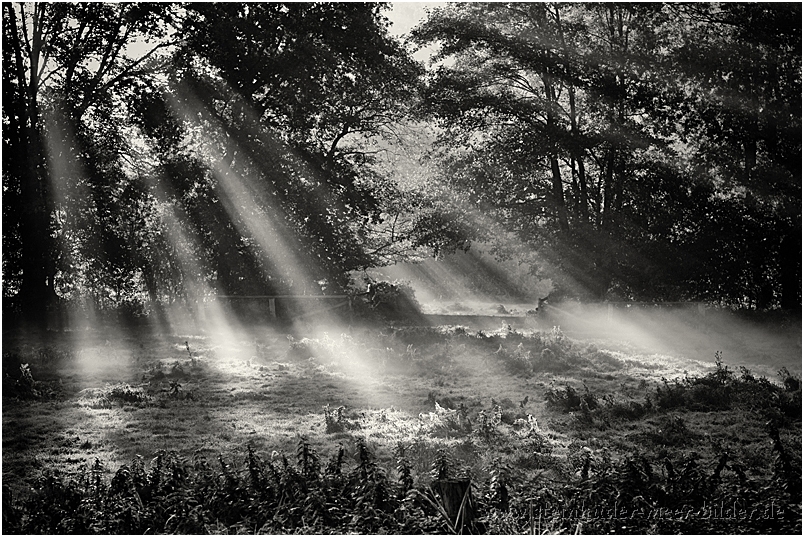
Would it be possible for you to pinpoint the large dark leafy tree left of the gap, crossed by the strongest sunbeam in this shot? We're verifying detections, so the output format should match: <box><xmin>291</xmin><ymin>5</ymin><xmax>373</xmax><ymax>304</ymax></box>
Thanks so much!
<box><xmin>154</xmin><ymin>3</ymin><xmax>419</xmax><ymax>289</ymax></box>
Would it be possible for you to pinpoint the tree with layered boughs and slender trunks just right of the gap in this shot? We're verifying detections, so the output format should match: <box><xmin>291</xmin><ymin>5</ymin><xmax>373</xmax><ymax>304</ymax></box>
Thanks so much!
<box><xmin>414</xmin><ymin>3</ymin><xmax>688</xmax><ymax>297</ymax></box>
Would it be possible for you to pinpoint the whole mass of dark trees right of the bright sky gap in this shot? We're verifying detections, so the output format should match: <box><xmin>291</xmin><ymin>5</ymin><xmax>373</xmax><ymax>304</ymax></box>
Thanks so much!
<box><xmin>413</xmin><ymin>2</ymin><xmax>801</xmax><ymax>309</ymax></box>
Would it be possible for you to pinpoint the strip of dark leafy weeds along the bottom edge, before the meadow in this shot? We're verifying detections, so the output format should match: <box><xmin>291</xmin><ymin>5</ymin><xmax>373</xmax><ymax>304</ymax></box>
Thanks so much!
<box><xmin>3</xmin><ymin>430</ymin><xmax>801</xmax><ymax>534</ymax></box>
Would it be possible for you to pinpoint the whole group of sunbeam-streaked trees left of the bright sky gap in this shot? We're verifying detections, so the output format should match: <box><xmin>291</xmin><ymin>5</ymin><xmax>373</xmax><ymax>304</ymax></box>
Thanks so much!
<box><xmin>3</xmin><ymin>3</ymin><xmax>440</xmax><ymax>321</ymax></box>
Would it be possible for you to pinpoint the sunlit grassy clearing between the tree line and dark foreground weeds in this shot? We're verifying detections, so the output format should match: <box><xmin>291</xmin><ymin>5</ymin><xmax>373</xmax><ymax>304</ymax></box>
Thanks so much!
<box><xmin>2</xmin><ymin>310</ymin><xmax>801</xmax><ymax>533</ymax></box>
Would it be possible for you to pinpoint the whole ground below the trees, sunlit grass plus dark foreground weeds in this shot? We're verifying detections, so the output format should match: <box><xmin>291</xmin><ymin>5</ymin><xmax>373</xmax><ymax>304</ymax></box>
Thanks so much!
<box><xmin>2</xmin><ymin>312</ymin><xmax>801</xmax><ymax>534</ymax></box>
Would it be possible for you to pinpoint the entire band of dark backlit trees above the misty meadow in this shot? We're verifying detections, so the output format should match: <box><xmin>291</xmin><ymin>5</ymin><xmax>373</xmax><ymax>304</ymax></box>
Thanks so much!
<box><xmin>2</xmin><ymin>2</ymin><xmax>801</xmax><ymax>321</ymax></box>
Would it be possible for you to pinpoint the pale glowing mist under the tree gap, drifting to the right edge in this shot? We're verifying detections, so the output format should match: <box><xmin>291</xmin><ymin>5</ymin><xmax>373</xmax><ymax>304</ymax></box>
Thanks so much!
<box><xmin>373</xmin><ymin>251</ymin><xmax>802</xmax><ymax>378</ymax></box>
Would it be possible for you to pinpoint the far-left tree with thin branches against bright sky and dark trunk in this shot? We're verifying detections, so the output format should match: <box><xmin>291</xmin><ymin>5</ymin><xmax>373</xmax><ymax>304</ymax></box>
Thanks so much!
<box><xmin>3</xmin><ymin>3</ymin><xmax>177</xmax><ymax>324</ymax></box>
